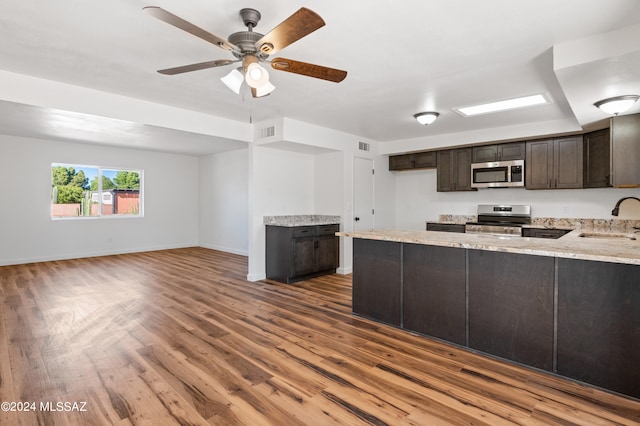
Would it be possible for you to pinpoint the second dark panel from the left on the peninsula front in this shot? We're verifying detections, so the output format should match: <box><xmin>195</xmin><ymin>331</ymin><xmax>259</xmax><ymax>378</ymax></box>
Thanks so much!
<box><xmin>402</xmin><ymin>244</ymin><xmax>467</xmax><ymax>345</ymax></box>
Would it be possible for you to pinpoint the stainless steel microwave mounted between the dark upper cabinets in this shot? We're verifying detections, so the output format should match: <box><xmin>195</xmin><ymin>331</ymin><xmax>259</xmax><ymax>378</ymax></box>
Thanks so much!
<box><xmin>471</xmin><ymin>160</ymin><xmax>524</xmax><ymax>188</ymax></box>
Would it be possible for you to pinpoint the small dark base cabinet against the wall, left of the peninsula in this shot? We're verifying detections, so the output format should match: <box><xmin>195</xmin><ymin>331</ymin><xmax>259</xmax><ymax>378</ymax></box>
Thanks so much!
<box><xmin>266</xmin><ymin>225</ymin><xmax>340</xmax><ymax>283</ymax></box>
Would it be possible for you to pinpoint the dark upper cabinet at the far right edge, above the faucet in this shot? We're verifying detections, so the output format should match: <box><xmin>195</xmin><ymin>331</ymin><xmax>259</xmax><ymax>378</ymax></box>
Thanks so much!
<box><xmin>611</xmin><ymin>114</ymin><xmax>640</xmax><ymax>188</ymax></box>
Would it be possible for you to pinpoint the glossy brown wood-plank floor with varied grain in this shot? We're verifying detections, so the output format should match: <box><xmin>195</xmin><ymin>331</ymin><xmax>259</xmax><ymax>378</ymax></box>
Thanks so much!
<box><xmin>0</xmin><ymin>248</ymin><xmax>640</xmax><ymax>425</ymax></box>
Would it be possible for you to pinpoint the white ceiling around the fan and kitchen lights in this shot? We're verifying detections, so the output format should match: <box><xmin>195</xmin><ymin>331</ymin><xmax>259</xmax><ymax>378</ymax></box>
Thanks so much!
<box><xmin>0</xmin><ymin>0</ymin><xmax>640</xmax><ymax>154</ymax></box>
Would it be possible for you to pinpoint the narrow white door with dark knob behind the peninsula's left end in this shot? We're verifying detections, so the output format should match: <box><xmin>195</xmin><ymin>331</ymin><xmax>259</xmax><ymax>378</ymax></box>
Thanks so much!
<box><xmin>353</xmin><ymin>157</ymin><xmax>374</xmax><ymax>231</ymax></box>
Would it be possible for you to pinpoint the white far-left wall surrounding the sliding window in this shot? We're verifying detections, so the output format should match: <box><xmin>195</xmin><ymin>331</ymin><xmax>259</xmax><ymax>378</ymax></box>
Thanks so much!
<box><xmin>0</xmin><ymin>135</ymin><xmax>198</xmax><ymax>265</ymax></box>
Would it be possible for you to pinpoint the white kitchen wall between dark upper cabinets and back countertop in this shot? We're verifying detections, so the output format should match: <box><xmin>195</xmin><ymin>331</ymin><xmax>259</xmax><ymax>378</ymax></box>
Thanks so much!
<box><xmin>394</xmin><ymin>169</ymin><xmax>640</xmax><ymax>229</ymax></box>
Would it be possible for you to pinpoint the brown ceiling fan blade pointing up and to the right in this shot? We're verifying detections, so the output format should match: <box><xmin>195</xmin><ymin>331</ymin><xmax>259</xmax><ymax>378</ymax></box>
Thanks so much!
<box><xmin>256</xmin><ymin>7</ymin><xmax>325</xmax><ymax>55</ymax></box>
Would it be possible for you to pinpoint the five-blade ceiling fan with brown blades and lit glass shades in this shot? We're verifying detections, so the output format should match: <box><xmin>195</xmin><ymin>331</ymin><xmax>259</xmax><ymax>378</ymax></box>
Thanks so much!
<box><xmin>143</xmin><ymin>6</ymin><xmax>347</xmax><ymax>98</ymax></box>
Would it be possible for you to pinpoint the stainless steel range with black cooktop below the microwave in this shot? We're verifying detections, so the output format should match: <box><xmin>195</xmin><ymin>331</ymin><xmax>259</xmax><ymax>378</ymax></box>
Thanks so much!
<box><xmin>465</xmin><ymin>204</ymin><xmax>531</xmax><ymax>237</ymax></box>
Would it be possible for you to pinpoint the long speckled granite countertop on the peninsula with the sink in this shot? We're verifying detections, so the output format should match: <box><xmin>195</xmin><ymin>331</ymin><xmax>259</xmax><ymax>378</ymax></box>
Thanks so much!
<box><xmin>336</xmin><ymin>228</ymin><xmax>640</xmax><ymax>265</ymax></box>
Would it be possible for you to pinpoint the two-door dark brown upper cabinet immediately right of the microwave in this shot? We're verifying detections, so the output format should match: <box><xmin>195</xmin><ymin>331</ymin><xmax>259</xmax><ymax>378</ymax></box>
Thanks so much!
<box><xmin>525</xmin><ymin>136</ymin><xmax>583</xmax><ymax>189</ymax></box>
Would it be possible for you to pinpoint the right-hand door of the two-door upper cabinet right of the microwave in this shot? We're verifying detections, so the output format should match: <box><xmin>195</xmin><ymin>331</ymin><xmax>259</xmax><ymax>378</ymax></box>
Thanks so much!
<box><xmin>553</xmin><ymin>136</ymin><xmax>583</xmax><ymax>189</ymax></box>
